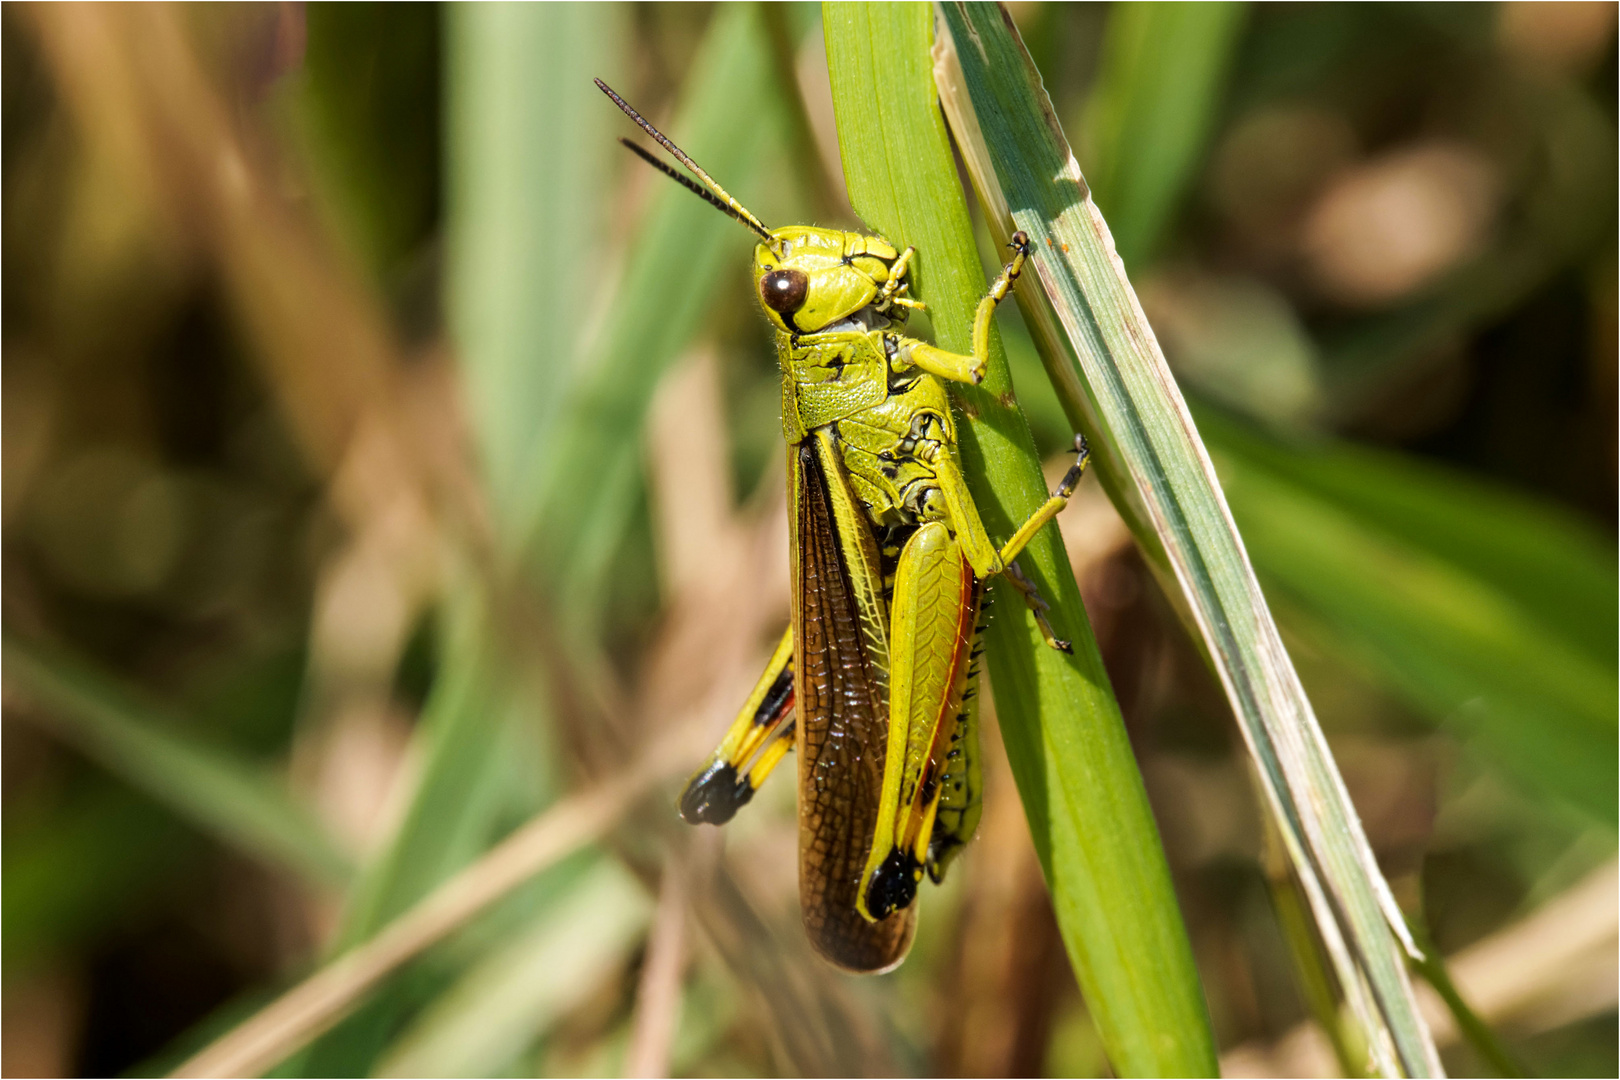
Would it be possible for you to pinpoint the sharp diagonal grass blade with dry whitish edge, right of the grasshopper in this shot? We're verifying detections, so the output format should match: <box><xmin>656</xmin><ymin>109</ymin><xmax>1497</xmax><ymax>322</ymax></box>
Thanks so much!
<box><xmin>940</xmin><ymin>3</ymin><xmax>1440</xmax><ymax>1075</ymax></box>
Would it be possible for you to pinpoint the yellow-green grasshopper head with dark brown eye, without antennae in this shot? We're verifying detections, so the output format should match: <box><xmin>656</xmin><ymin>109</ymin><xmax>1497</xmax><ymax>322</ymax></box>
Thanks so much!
<box><xmin>753</xmin><ymin>233</ymin><xmax>899</xmax><ymax>334</ymax></box>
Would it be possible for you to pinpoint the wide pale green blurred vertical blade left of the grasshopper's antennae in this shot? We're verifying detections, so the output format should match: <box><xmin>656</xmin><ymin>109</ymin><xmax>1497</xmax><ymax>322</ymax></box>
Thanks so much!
<box><xmin>446</xmin><ymin>3</ymin><xmax>630</xmax><ymax>549</ymax></box>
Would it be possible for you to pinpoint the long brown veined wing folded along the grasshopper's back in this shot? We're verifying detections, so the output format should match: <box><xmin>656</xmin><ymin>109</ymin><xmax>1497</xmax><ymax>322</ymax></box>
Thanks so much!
<box><xmin>789</xmin><ymin>434</ymin><xmax>915</xmax><ymax>972</ymax></box>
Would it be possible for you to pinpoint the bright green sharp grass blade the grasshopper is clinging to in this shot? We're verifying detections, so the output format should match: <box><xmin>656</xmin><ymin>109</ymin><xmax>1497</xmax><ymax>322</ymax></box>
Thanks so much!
<box><xmin>823</xmin><ymin>3</ymin><xmax>1215</xmax><ymax>1075</ymax></box>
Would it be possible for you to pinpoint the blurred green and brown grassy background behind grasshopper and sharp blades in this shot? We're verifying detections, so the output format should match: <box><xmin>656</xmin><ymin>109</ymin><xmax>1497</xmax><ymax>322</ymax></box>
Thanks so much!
<box><xmin>0</xmin><ymin>3</ymin><xmax>1620</xmax><ymax>1075</ymax></box>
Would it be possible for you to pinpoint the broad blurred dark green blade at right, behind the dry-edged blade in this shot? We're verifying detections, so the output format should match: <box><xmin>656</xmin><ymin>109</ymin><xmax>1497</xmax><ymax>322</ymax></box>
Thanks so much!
<box><xmin>1215</xmin><ymin>424</ymin><xmax>1620</xmax><ymax>823</ymax></box>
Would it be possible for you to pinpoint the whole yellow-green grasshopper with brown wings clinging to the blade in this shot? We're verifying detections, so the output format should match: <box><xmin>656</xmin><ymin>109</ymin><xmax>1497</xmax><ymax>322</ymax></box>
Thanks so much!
<box><xmin>596</xmin><ymin>79</ymin><xmax>1089</xmax><ymax>972</ymax></box>
